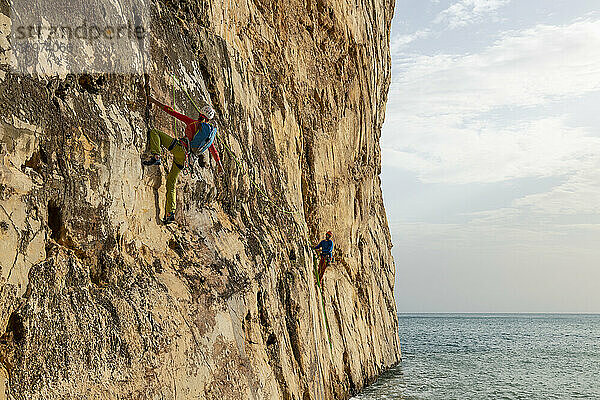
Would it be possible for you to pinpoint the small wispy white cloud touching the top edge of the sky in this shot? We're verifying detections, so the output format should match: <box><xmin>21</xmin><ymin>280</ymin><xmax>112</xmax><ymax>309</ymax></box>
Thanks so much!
<box><xmin>434</xmin><ymin>0</ymin><xmax>510</xmax><ymax>29</ymax></box>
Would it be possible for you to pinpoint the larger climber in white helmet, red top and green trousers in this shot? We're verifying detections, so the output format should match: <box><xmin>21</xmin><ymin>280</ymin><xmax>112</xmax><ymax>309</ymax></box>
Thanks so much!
<box><xmin>142</xmin><ymin>97</ymin><xmax>223</xmax><ymax>224</ymax></box>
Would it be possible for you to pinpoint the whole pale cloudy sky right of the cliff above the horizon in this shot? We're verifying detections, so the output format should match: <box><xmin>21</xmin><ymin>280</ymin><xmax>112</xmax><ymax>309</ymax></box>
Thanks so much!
<box><xmin>381</xmin><ymin>0</ymin><xmax>600</xmax><ymax>312</ymax></box>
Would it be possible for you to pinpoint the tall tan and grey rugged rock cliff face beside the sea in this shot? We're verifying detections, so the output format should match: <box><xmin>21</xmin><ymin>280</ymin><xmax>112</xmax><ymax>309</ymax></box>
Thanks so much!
<box><xmin>0</xmin><ymin>0</ymin><xmax>400</xmax><ymax>400</ymax></box>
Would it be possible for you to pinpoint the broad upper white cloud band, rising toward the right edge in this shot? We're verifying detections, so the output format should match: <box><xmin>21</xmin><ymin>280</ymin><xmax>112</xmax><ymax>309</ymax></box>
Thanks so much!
<box><xmin>390</xmin><ymin>20</ymin><xmax>600</xmax><ymax>113</ymax></box>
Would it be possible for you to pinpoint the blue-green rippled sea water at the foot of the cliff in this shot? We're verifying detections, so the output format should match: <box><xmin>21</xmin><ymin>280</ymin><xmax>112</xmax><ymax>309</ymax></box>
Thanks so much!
<box><xmin>354</xmin><ymin>314</ymin><xmax>600</xmax><ymax>400</ymax></box>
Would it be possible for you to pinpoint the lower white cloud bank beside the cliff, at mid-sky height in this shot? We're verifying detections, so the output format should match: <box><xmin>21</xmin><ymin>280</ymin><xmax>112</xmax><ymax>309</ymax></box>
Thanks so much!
<box><xmin>383</xmin><ymin>117</ymin><xmax>600</xmax><ymax>184</ymax></box>
